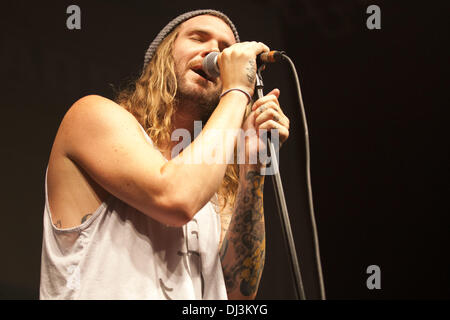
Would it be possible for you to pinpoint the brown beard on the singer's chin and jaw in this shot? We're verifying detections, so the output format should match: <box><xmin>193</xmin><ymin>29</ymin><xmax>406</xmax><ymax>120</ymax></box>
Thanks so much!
<box><xmin>175</xmin><ymin>72</ymin><xmax>222</xmax><ymax>122</ymax></box>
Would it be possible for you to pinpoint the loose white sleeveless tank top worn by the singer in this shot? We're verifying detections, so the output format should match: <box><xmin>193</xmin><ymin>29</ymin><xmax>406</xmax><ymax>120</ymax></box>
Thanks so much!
<box><xmin>40</xmin><ymin>127</ymin><xmax>227</xmax><ymax>300</ymax></box>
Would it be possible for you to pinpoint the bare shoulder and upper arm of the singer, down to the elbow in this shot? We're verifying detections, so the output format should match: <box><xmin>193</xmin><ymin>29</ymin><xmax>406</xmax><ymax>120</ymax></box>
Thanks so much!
<box><xmin>48</xmin><ymin>95</ymin><xmax>184</xmax><ymax>225</ymax></box>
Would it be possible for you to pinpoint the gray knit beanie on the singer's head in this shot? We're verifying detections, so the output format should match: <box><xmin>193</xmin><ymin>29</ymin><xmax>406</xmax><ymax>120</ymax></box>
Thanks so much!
<box><xmin>143</xmin><ymin>9</ymin><xmax>240</xmax><ymax>70</ymax></box>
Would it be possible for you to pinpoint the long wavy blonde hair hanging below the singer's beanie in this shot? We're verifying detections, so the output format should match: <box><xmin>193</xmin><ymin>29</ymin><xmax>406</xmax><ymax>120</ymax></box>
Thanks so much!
<box><xmin>115</xmin><ymin>27</ymin><xmax>243</xmax><ymax>209</ymax></box>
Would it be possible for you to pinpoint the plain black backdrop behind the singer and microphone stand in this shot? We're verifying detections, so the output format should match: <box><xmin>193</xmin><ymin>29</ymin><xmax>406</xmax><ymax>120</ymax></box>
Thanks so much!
<box><xmin>0</xmin><ymin>0</ymin><xmax>450</xmax><ymax>299</ymax></box>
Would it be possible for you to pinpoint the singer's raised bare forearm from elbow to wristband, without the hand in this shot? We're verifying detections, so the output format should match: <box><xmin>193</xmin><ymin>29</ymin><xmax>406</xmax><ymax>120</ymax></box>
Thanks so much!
<box><xmin>161</xmin><ymin>91</ymin><xmax>247</xmax><ymax>215</ymax></box>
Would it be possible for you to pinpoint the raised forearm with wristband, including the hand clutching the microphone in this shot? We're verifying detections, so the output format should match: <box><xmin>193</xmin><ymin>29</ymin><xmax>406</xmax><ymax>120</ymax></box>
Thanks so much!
<box><xmin>161</xmin><ymin>42</ymin><xmax>269</xmax><ymax>217</ymax></box>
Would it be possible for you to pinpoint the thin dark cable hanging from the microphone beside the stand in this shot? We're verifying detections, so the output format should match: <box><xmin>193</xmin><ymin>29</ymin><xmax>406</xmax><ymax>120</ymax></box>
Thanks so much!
<box><xmin>281</xmin><ymin>52</ymin><xmax>326</xmax><ymax>300</ymax></box>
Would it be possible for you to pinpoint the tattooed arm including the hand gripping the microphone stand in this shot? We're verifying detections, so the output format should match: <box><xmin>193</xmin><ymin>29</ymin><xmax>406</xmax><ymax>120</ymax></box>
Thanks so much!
<box><xmin>220</xmin><ymin>89</ymin><xmax>289</xmax><ymax>299</ymax></box>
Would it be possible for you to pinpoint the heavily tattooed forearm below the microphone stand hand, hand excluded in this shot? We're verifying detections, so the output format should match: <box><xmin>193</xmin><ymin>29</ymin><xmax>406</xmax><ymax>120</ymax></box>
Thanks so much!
<box><xmin>220</xmin><ymin>166</ymin><xmax>266</xmax><ymax>299</ymax></box>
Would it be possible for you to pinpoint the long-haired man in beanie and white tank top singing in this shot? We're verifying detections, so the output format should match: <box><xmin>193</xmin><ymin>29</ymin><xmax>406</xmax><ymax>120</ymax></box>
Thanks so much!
<box><xmin>40</xmin><ymin>10</ymin><xmax>289</xmax><ymax>299</ymax></box>
